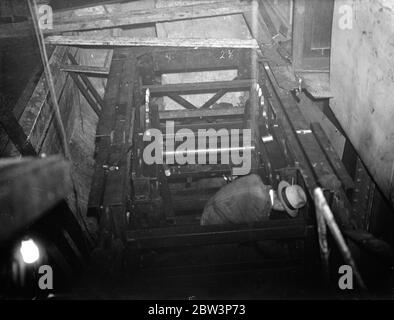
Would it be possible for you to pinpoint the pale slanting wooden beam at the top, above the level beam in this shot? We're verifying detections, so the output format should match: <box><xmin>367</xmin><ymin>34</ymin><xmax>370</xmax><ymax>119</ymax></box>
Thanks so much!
<box><xmin>0</xmin><ymin>0</ymin><xmax>251</xmax><ymax>39</ymax></box>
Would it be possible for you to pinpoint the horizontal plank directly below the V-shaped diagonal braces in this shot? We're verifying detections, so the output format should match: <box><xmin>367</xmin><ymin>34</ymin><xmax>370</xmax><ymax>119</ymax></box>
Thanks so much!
<box><xmin>160</xmin><ymin>107</ymin><xmax>244</xmax><ymax>120</ymax></box>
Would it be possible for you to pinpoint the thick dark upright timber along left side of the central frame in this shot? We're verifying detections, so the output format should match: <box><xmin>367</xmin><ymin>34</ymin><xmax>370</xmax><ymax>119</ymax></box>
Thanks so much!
<box><xmin>89</xmin><ymin>49</ymin><xmax>137</xmax><ymax>237</ymax></box>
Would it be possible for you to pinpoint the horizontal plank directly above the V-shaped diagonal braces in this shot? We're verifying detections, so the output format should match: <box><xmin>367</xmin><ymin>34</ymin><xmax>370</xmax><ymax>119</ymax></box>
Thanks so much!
<box><xmin>142</xmin><ymin>79</ymin><xmax>253</xmax><ymax>95</ymax></box>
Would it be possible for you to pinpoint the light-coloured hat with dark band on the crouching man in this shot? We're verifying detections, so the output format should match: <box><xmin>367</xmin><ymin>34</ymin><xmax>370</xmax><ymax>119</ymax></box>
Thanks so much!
<box><xmin>278</xmin><ymin>181</ymin><xmax>306</xmax><ymax>218</ymax></box>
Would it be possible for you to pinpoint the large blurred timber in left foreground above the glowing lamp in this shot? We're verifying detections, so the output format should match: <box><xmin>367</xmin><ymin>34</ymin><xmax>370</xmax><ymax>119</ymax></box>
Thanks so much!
<box><xmin>0</xmin><ymin>156</ymin><xmax>72</xmax><ymax>242</ymax></box>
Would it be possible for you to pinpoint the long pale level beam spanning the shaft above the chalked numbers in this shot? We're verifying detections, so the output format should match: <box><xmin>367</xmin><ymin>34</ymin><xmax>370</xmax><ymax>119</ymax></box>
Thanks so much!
<box><xmin>45</xmin><ymin>35</ymin><xmax>259</xmax><ymax>49</ymax></box>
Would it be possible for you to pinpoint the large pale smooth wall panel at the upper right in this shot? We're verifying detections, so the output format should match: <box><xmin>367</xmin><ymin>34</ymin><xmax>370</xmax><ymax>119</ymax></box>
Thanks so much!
<box><xmin>330</xmin><ymin>0</ymin><xmax>394</xmax><ymax>203</ymax></box>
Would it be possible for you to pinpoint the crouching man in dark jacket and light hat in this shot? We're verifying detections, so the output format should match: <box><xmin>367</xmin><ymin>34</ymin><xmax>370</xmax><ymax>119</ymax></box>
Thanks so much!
<box><xmin>200</xmin><ymin>174</ymin><xmax>306</xmax><ymax>225</ymax></box>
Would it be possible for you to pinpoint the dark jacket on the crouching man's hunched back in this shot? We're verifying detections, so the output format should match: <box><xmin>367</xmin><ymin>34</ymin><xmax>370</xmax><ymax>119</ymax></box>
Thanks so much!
<box><xmin>201</xmin><ymin>174</ymin><xmax>272</xmax><ymax>225</ymax></box>
